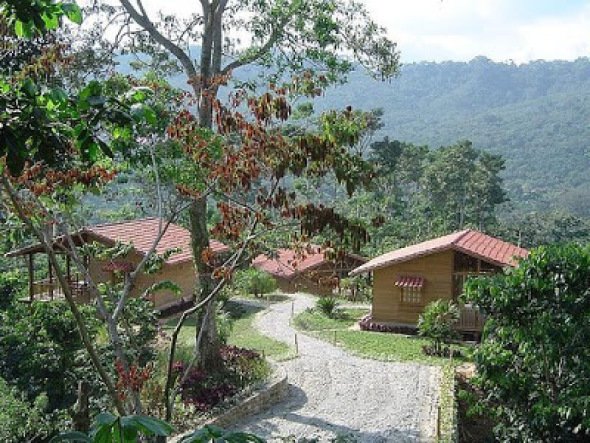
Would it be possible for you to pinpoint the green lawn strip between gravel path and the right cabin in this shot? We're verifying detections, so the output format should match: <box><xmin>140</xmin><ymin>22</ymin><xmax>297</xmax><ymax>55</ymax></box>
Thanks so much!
<box><xmin>293</xmin><ymin>309</ymin><xmax>469</xmax><ymax>365</ymax></box>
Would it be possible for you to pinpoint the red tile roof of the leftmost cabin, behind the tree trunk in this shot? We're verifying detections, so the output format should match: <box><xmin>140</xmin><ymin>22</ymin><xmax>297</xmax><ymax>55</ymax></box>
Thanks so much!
<box><xmin>82</xmin><ymin>218</ymin><xmax>229</xmax><ymax>264</ymax></box>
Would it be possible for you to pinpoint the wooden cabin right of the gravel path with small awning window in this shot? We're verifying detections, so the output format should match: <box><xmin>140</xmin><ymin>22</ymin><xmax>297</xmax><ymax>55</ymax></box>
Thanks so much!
<box><xmin>351</xmin><ymin>229</ymin><xmax>528</xmax><ymax>333</ymax></box>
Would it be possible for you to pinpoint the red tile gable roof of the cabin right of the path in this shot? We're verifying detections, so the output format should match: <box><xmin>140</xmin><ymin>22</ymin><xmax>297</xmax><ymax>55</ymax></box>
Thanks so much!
<box><xmin>350</xmin><ymin>229</ymin><xmax>528</xmax><ymax>275</ymax></box>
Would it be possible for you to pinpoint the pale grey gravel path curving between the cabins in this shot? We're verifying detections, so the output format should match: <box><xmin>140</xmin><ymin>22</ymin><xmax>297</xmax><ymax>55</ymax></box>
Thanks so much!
<box><xmin>229</xmin><ymin>294</ymin><xmax>440</xmax><ymax>443</ymax></box>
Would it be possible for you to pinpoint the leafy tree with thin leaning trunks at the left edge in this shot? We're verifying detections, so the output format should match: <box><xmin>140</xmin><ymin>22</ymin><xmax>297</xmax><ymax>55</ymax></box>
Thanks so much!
<box><xmin>0</xmin><ymin>1</ymin><xmax>173</xmax><ymax>414</ymax></box>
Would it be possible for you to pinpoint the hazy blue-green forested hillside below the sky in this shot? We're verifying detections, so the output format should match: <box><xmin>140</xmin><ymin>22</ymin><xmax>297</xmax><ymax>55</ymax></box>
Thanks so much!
<box><xmin>317</xmin><ymin>57</ymin><xmax>590</xmax><ymax>216</ymax></box>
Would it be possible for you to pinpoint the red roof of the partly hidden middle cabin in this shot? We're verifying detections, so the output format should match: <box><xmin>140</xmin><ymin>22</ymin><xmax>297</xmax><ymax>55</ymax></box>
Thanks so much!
<box><xmin>252</xmin><ymin>246</ymin><xmax>338</xmax><ymax>279</ymax></box>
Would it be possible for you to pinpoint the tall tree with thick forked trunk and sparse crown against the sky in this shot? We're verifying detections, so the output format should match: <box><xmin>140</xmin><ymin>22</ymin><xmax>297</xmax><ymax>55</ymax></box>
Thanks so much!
<box><xmin>83</xmin><ymin>0</ymin><xmax>399</xmax><ymax>369</ymax></box>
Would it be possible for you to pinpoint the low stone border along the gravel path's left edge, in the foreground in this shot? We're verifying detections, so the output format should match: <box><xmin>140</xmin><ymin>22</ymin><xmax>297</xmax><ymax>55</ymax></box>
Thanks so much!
<box><xmin>169</xmin><ymin>363</ymin><xmax>289</xmax><ymax>443</ymax></box>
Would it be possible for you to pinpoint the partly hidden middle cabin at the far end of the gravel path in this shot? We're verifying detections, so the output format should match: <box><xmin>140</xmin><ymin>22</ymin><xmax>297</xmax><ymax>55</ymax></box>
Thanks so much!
<box><xmin>252</xmin><ymin>245</ymin><xmax>367</xmax><ymax>296</ymax></box>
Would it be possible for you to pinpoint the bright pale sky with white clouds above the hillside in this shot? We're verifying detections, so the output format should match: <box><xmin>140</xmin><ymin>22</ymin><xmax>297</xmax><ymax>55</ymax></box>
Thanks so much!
<box><xmin>107</xmin><ymin>0</ymin><xmax>590</xmax><ymax>63</ymax></box>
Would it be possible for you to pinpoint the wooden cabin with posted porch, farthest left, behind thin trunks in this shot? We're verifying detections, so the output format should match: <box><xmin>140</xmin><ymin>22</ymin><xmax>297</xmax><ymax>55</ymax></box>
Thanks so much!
<box><xmin>6</xmin><ymin>218</ymin><xmax>229</xmax><ymax>309</ymax></box>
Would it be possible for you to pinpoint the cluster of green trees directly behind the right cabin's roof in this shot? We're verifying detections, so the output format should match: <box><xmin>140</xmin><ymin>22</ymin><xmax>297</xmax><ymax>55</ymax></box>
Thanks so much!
<box><xmin>297</xmin><ymin>137</ymin><xmax>506</xmax><ymax>256</ymax></box>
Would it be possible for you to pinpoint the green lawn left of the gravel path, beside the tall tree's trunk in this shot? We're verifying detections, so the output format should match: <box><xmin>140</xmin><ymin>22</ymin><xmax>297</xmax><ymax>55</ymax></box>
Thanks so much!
<box><xmin>164</xmin><ymin>300</ymin><xmax>294</xmax><ymax>360</ymax></box>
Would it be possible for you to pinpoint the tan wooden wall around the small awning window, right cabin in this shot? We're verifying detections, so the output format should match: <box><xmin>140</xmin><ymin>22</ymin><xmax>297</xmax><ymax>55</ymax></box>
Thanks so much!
<box><xmin>372</xmin><ymin>250</ymin><xmax>453</xmax><ymax>325</ymax></box>
